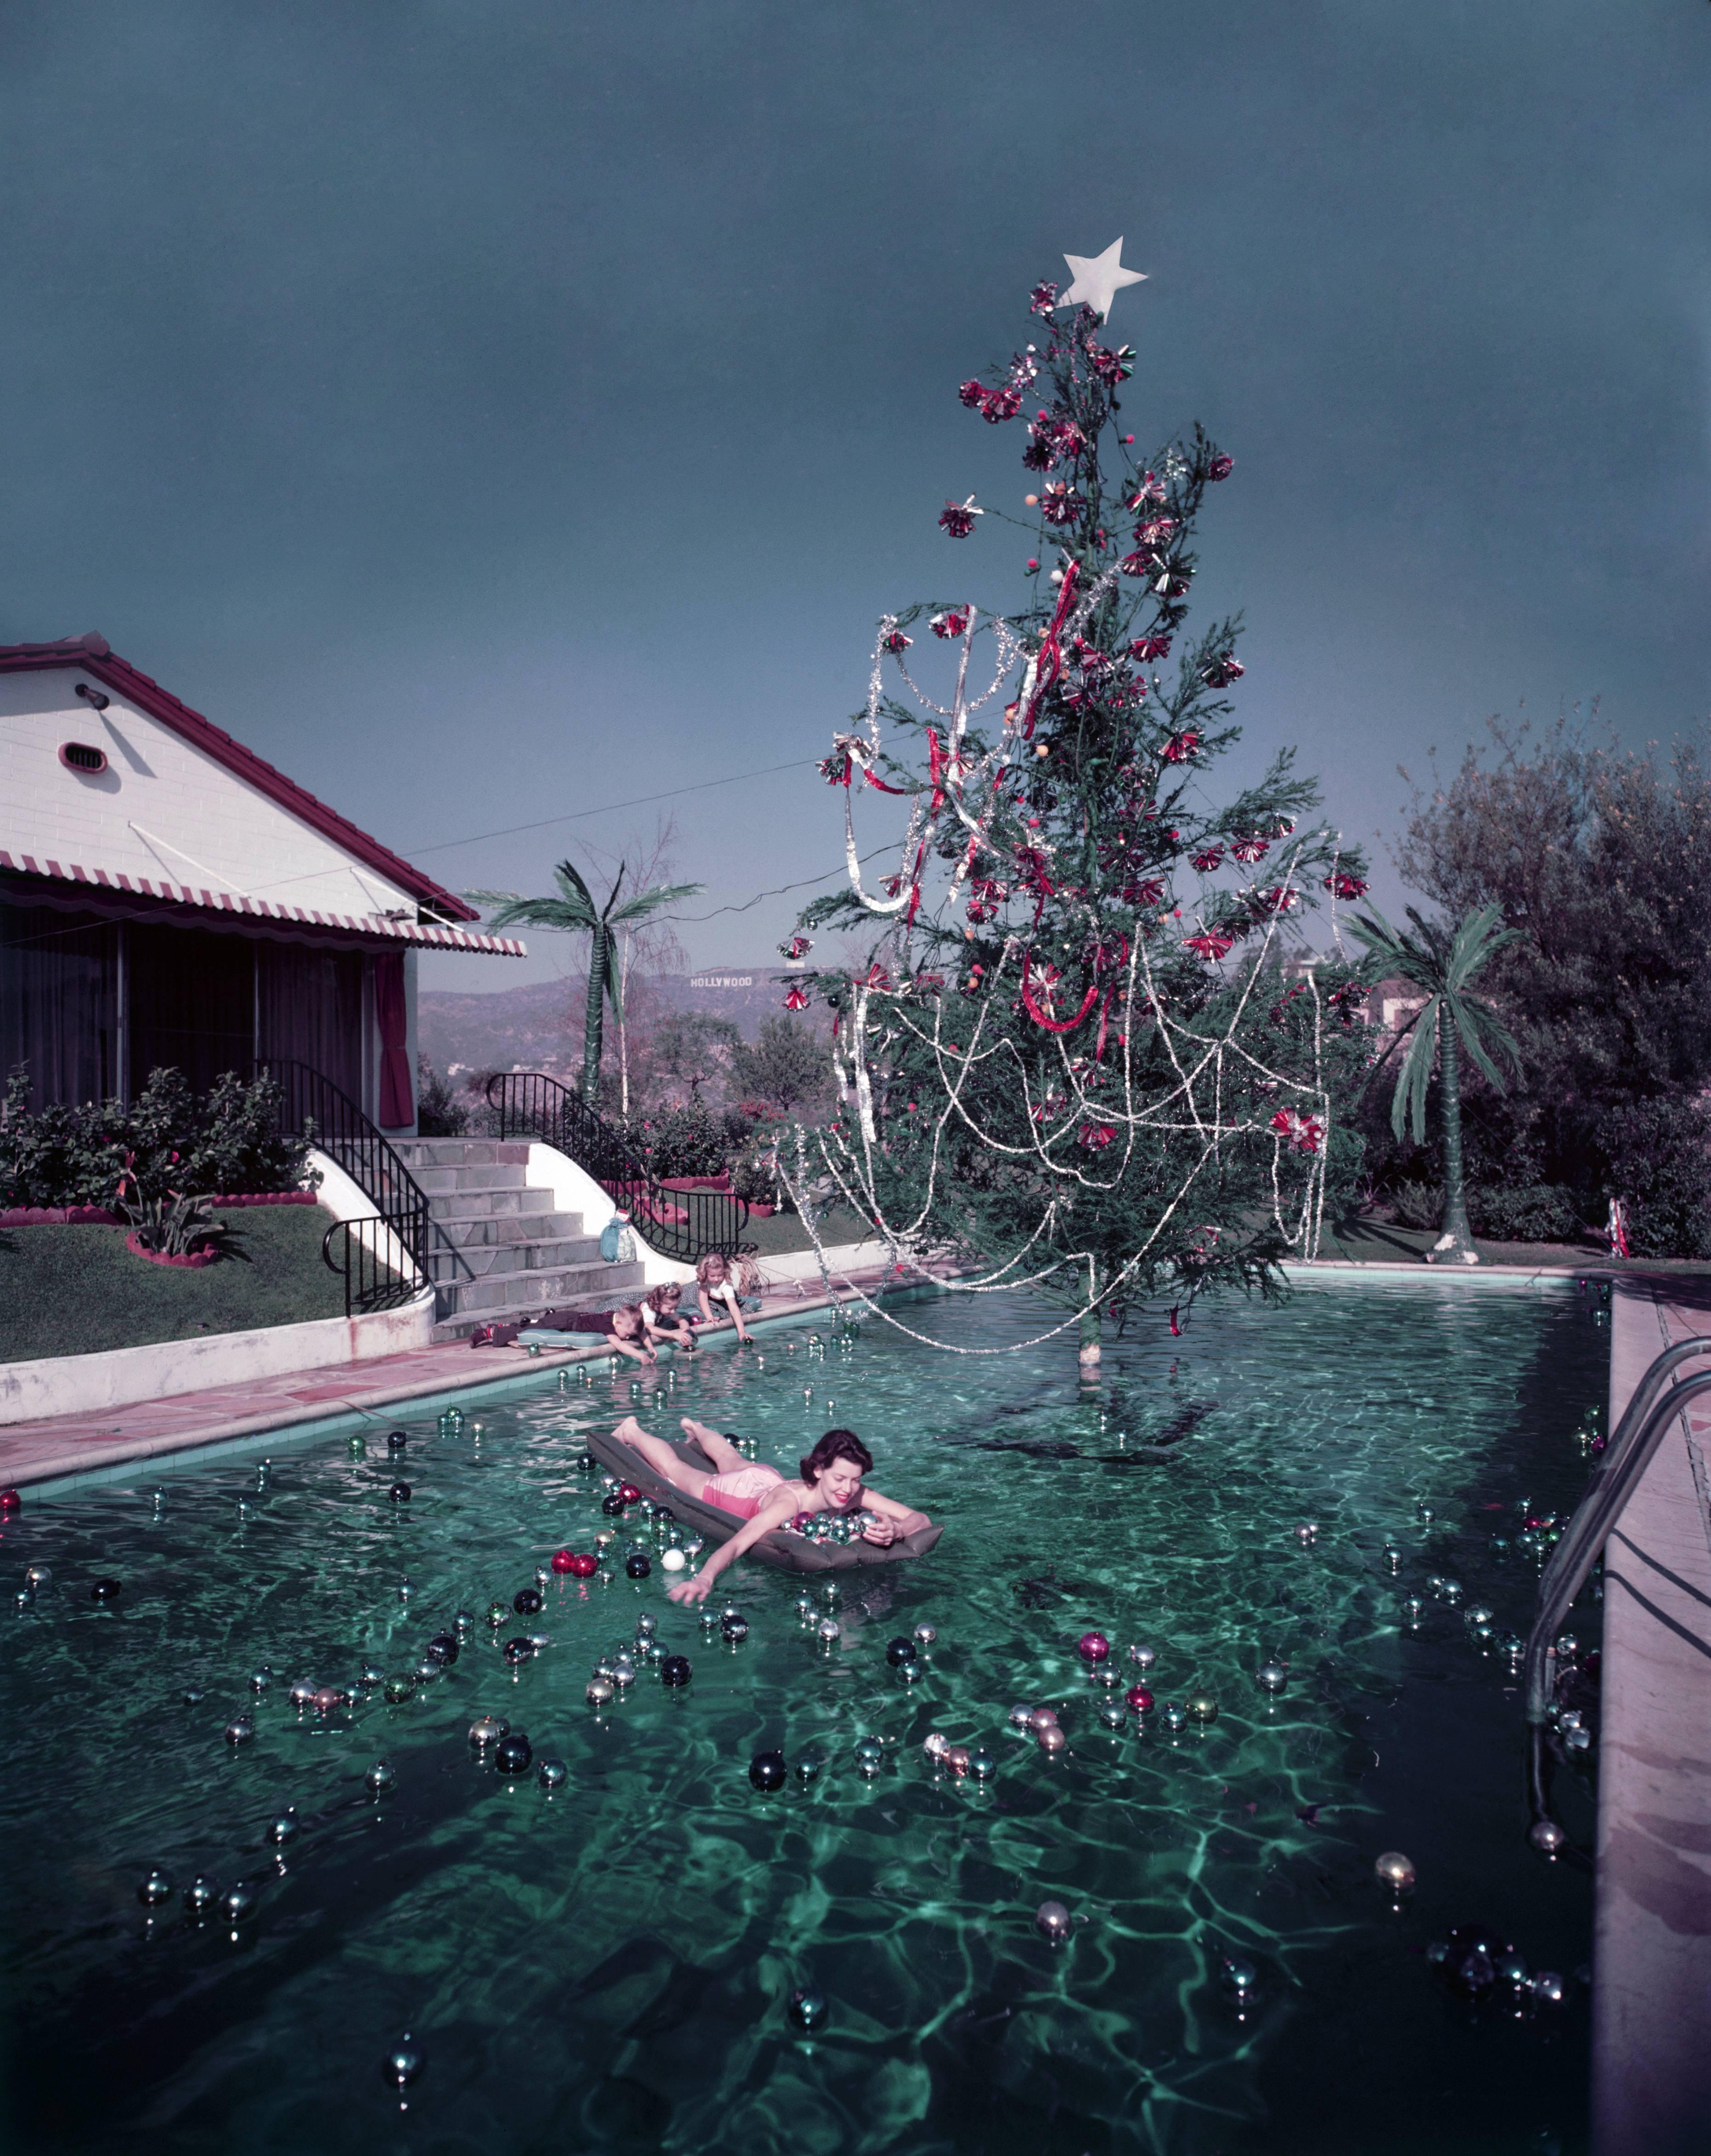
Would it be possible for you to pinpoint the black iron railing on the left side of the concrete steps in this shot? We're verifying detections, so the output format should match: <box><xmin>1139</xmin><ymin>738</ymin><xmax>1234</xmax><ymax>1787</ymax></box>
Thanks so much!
<box><xmin>256</xmin><ymin>1057</ymin><xmax>474</xmax><ymax>1317</ymax></box>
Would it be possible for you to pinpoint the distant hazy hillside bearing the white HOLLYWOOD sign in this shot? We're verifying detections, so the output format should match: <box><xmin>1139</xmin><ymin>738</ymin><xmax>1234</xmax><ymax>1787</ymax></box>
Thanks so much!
<box><xmin>416</xmin><ymin>966</ymin><xmax>782</xmax><ymax>1076</ymax></box>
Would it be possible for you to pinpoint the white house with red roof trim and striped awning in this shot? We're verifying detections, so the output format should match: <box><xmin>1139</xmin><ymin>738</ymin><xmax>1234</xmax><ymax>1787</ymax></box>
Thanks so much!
<box><xmin>0</xmin><ymin>636</ymin><xmax>523</xmax><ymax>1134</ymax></box>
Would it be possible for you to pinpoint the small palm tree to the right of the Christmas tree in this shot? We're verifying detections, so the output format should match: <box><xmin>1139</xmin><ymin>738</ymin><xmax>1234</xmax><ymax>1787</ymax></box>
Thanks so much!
<box><xmin>1349</xmin><ymin>906</ymin><xmax>1521</xmax><ymax>1266</ymax></box>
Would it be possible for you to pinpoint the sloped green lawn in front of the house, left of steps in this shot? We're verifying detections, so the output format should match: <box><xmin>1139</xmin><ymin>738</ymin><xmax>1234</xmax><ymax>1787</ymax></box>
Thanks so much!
<box><xmin>0</xmin><ymin>1205</ymin><xmax>345</xmax><ymax>1362</ymax></box>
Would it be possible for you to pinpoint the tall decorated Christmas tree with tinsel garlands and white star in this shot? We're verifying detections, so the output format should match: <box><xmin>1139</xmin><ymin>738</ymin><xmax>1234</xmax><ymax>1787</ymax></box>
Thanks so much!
<box><xmin>782</xmin><ymin>250</ymin><xmax>1366</xmax><ymax>1367</ymax></box>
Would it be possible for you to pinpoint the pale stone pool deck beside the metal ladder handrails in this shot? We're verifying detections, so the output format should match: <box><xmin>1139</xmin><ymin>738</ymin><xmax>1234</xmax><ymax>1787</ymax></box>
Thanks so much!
<box><xmin>1593</xmin><ymin>1276</ymin><xmax>1711</xmax><ymax>2156</ymax></box>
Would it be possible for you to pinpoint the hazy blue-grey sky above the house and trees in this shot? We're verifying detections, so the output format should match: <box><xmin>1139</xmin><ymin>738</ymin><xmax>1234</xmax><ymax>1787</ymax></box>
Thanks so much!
<box><xmin>0</xmin><ymin>0</ymin><xmax>1711</xmax><ymax>992</ymax></box>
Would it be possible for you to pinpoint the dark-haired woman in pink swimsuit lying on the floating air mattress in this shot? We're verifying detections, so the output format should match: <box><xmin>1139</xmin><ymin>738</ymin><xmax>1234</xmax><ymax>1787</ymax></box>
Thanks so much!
<box><xmin>612</xmin><ymin>1414</ymin><xmax>933</xmax><ymax>1602</ymax></box>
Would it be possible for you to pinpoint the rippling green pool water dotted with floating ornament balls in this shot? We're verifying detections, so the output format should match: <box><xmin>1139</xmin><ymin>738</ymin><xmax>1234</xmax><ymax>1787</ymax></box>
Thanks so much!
<box><xmin>0</xmin><ymin>1283</ymin><xmax>1608</xmax><ymax>2156</ymax></box>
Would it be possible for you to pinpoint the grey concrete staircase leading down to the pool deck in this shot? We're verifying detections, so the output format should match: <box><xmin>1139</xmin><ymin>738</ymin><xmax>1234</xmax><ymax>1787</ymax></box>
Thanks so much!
<box><xmin>396</xmin><ymin>1138</ymin><xmax>642</xmax><ymax>1341</ymax></box>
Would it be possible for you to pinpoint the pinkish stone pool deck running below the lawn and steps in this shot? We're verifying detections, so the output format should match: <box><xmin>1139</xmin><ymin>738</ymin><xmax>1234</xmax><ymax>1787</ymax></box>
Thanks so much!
<box><xmin>0</xmin><ymin>1246</ymin><xmax>888</xmax><ymax>1490</ymax></box>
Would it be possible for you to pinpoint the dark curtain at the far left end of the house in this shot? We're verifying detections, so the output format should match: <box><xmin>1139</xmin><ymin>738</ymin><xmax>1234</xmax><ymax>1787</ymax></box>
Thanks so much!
<box><xmin>0</xmin><ymin>901</ymin><xmax>118</xmax><ymax>1110</ymax></box>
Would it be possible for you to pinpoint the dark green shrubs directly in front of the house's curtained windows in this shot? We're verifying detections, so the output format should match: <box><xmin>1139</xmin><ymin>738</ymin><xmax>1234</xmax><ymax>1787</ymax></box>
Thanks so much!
<box><xmin>0</xmin><ymin>1070</ymin><xmax>310</xmax><ymax>1210</ymax></box>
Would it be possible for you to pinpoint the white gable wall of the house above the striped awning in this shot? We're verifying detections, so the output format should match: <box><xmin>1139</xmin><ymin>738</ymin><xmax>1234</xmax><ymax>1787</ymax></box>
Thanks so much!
<box><xmin>0</xmin><ymin>666</ymin><xmax>416</xmax><ymax>921</ymax></box>
